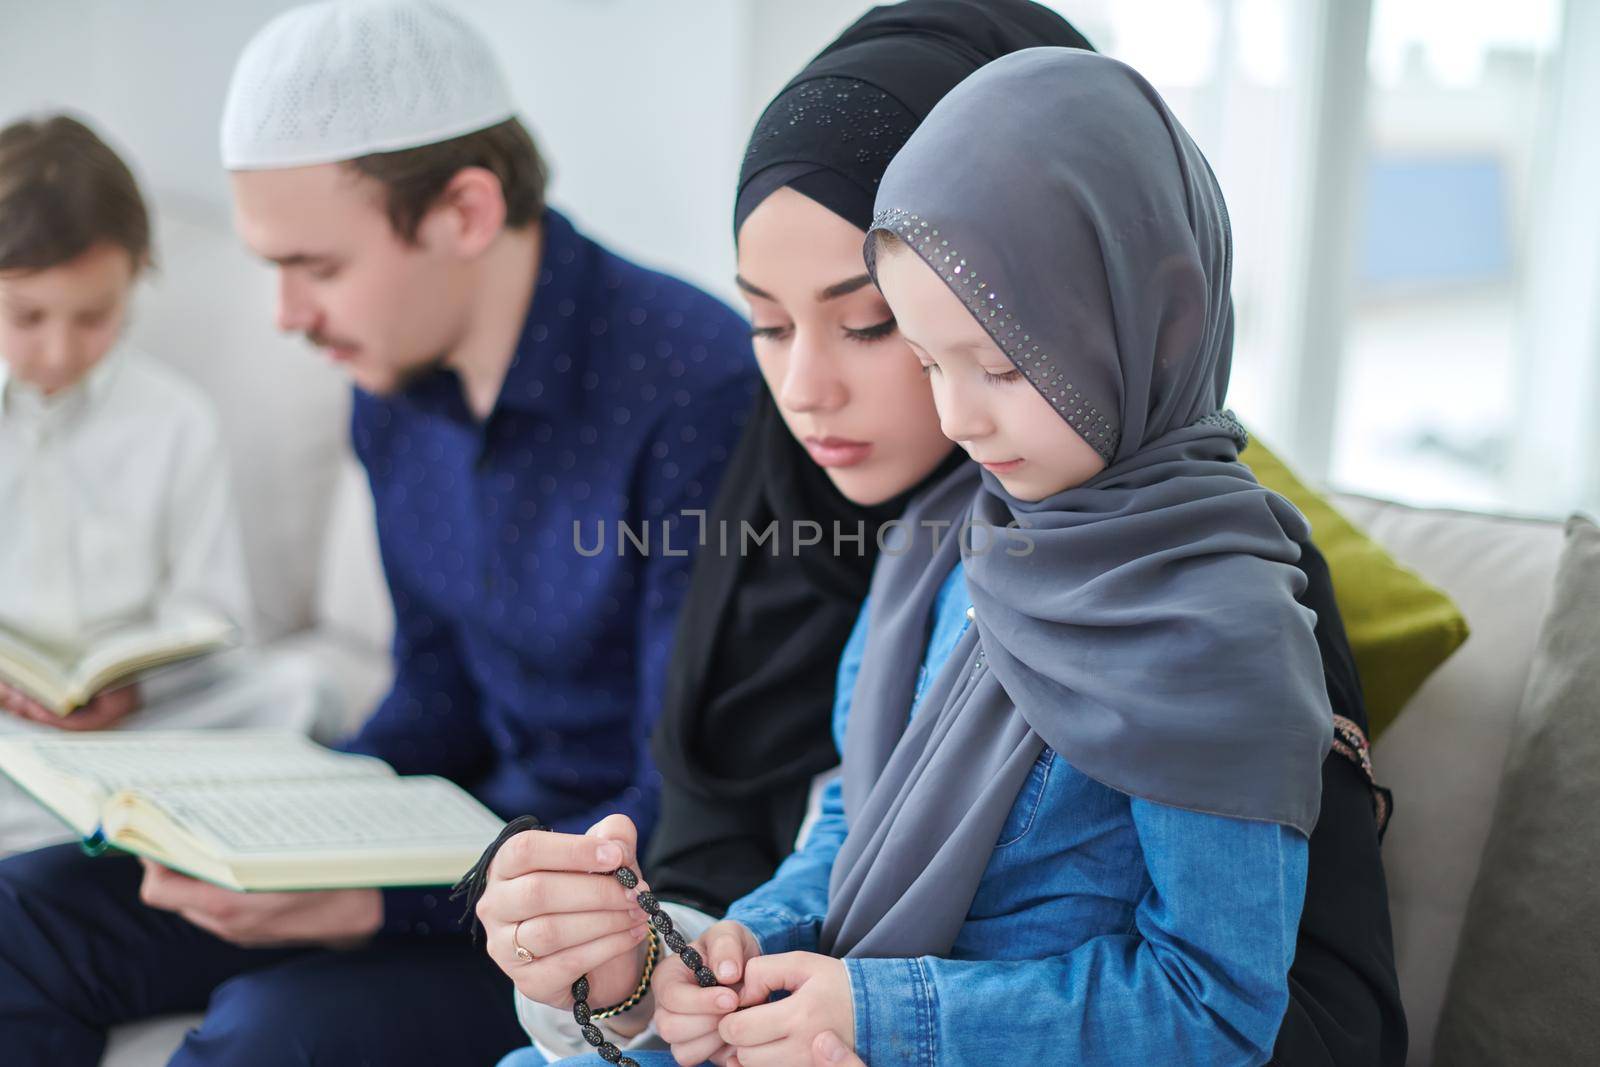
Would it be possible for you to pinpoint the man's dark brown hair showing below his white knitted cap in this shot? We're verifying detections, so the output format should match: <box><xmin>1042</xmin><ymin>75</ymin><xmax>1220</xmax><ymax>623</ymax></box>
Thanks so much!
<box><xmin>349</xmin><ymin>118</ymin><xmax>549</xmax><ymax>243</ymax></box>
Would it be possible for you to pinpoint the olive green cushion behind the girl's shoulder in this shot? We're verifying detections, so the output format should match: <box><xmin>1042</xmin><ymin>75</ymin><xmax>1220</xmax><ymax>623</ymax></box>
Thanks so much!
<box><xmin>1240</xmin><ymin>440</ymin><xmax>1467</xmax><ymax>741</ymax></box>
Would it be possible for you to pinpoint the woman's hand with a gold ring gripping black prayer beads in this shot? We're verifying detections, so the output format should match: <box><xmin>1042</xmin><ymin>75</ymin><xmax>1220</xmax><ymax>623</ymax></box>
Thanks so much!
<box><xmin>477</xmin><ymin>814</ymin><xmax>648</xmax><ymax>1022</ymax></box>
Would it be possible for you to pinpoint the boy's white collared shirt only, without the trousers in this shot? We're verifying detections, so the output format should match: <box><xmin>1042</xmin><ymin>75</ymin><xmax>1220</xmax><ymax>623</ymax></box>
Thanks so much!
<box><xmin>0</xmin><ymin>346</ymin><xmax>251</xmax><ymax>649</ymax></box>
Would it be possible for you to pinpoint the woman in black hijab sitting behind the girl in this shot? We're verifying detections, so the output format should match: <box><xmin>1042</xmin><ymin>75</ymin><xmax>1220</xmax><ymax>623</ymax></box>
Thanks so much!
<box><xmin>483</xmin><ymin>0</ymin><xmax>1405</xmax><ymax>1064</ymax></box>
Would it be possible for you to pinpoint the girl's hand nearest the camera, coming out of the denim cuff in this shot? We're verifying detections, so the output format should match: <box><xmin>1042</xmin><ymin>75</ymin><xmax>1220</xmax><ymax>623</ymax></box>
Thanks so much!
<box><xmin>720</xmin><ymin>952</ymin><xmax>856</xmax><ymax>1067</ymax></box>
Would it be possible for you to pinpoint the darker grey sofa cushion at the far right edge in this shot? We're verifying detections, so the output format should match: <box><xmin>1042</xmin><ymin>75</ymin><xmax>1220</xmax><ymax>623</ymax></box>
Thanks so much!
<box><xmin>1437</xmin><ymin>518</ymin><xmax>1600</xmax><ymax>1067</ymax></box>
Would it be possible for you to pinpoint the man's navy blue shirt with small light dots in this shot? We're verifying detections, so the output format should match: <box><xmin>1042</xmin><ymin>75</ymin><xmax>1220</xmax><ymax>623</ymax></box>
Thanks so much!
<box><xmin>344</xmin><ymin>211</ymin><xmax>758</xmax><ymax>933</ymax></box>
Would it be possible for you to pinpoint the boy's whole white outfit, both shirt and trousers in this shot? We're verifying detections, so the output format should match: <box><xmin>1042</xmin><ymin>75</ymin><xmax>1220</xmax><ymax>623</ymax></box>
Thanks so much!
<box><xmin>0</xmin><ymin>344</ymin><xmax>339</xmax><ymax>856</ymax></box>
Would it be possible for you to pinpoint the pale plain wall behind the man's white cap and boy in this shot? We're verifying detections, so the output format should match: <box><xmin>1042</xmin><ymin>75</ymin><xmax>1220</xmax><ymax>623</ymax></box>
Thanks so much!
<box><xmin>0</xmin><ymin>0</ymin><xmax>749</xmax><ymax>296</ymax></box>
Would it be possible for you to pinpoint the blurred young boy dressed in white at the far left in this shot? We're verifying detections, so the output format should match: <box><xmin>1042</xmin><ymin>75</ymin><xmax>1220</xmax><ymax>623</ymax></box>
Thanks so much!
<box><xmin>0</xmin><ymin>115</ymin><xmax>338</xmax><ymax>856</ymax></box>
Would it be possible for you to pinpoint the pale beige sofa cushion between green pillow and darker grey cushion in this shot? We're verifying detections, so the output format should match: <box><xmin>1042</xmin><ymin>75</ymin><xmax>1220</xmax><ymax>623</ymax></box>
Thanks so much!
<box><xmin>1333</xmin><ymin>496</ymin><xmax>1562</xmax><ymax>1064</ymax></box>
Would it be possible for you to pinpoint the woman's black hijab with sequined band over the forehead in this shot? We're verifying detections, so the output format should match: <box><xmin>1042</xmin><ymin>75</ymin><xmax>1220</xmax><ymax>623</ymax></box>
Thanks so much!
<box><xmin>646</xmin><ymin>0</ymin><xmax>1090</xmax><ymax>913</ymax></box>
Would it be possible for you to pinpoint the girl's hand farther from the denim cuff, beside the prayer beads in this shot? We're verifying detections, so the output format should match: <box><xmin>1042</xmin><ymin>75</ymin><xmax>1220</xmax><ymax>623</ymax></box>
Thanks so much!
<box><xmin>654</xmin><ymin>920</ymin><xmax>762</xmax><ymax>1067</ymax></box>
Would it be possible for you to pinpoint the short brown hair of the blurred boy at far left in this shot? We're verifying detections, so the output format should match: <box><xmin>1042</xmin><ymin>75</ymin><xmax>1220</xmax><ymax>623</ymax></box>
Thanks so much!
<box><xmin>0</xmin><ymin>115</ymin><xmax>150</xmax><ymax>272</ymax></box>
